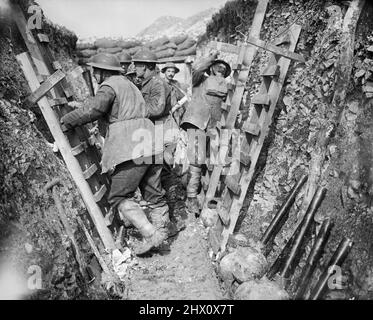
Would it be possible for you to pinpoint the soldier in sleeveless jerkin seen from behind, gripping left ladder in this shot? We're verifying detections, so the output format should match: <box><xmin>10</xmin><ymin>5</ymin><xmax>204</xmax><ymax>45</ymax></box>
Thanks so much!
<box><xmin>61</xmin><ymin>53</ymin><xmax>169</xmax><ymax>254</ymax></box>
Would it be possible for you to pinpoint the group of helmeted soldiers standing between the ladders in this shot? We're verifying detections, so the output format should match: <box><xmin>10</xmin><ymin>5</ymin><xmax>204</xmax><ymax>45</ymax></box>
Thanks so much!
<box><xmin>61</xmin><ymin>49</ymin><xmax>231</xmax><ymax>255</ymax></box>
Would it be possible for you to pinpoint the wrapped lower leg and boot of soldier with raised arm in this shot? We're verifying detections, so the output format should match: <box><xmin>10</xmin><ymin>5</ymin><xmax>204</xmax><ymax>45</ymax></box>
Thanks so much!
<box><xmin>186</xmin><ymin>165</ymin><xmax>202</xmax><ymax>217</ymax></box>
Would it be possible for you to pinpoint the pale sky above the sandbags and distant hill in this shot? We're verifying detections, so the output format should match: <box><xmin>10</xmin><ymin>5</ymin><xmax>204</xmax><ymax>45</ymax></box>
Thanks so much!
<box><xmin>37</xmin><ymin>0</ymin><xmax>227</xmax><ymax>39</ymax></box>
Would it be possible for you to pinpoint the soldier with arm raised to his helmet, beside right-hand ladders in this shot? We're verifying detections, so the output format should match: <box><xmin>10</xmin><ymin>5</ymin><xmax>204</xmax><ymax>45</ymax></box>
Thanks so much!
<box><xmin>181</xmin><ymin>52</ymin><xmax>231</xmax><ymax>216</ymax></box>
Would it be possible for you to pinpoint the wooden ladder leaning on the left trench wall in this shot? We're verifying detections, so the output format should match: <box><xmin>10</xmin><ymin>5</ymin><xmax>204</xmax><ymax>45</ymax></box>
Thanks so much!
<box><xmin>11</xmin><ymin>4</ymin><xmax>115</xmax><ymax>250</ymax></box>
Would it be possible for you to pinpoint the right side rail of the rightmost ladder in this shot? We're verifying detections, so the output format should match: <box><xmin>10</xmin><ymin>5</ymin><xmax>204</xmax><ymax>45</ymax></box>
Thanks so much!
<box><xmin>220</xmin><ymin>24</ymin><xmax>301</xmax><ymax>252</ymax></box>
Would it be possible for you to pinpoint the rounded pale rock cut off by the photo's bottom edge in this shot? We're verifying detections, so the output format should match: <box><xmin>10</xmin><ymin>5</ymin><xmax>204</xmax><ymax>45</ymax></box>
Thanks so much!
<box><xmin>235</xmin><ymin>278</ymin><xmax>289</xmax><ymax>300</ymax></box>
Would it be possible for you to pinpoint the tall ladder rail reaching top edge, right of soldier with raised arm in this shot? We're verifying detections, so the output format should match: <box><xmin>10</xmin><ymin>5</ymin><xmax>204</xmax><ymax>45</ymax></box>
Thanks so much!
<box><xmin>201</xmin><ymin>0</ymin><xmax>269</xmax><ymax>221</ymax></box>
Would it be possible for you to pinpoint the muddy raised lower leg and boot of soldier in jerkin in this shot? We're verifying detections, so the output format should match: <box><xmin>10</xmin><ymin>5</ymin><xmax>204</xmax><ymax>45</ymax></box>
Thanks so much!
<box><xmin>118</xmin><ymin>199</ymin><xmax>165</xmax><ymax>255</ymax></box>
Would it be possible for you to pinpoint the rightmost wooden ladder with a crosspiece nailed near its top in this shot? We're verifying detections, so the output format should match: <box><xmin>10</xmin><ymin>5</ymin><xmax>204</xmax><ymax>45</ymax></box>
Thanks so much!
<box><xmin>202</xmin><ymin>25</ymin><xmax>304</xmax><ymax>253</ymax></box>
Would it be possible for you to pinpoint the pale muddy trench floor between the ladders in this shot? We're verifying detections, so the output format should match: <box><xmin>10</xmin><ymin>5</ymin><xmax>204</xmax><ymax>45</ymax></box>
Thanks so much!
<box><xmin>122</xmin><ymin>170</ymin><xmax>225</xmax><ymax>300</ymax></box>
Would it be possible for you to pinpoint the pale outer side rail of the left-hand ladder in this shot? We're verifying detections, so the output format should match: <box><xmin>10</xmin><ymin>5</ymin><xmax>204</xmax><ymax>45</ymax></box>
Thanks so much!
<box><xmin>16</xmin><ymin>53</ymin><xmax>116</xmax><ymax>250</ymax></box>
